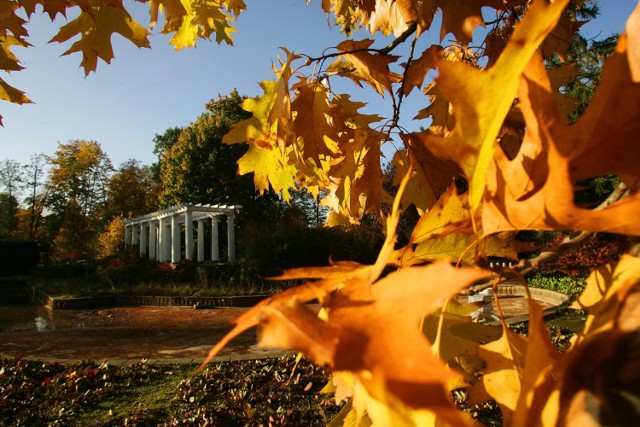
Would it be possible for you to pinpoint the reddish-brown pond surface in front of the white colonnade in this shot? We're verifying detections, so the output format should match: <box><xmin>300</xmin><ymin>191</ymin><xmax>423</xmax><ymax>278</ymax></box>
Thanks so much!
<box><xmin>0</xmin><ymin>306</ymin><xmax>282</xmax><ymax>362</ymax></box>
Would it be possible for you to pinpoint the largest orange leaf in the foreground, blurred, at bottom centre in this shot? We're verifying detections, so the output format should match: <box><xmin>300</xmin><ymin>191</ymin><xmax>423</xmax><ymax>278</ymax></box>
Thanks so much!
<box><xmin>205</xmin><ymin>262</ymin><xmax>487</xmax><ymax>422</ymax></box>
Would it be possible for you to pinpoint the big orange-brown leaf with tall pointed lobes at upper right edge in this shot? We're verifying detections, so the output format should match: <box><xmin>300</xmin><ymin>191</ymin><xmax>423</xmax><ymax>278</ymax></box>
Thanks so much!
<box><xmin>482</xmin><ymin>15</ymin><xmax>640</xmax><ymax>235</ymax></box>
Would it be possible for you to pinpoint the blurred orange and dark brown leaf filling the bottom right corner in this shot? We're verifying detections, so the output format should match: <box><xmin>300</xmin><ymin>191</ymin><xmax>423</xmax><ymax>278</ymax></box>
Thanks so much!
<box><xmin>531</xmin><ymin>255</ymin><xmax>640</xmax><ymax>426</ymax></box>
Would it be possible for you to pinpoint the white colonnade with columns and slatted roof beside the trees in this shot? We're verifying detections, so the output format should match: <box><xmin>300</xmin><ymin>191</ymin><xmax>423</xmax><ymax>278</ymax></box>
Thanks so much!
<box><xmin>122</xmin><ymin>203</ymin><xmax>240</xmax><ymax>262</ymax></box>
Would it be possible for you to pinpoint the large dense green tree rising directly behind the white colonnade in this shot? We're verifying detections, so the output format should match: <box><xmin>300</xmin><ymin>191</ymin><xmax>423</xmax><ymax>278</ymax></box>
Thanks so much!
<box><xmin>154</xmin><ymin>90</ymin><xmax>280</xmax><ymax>224</ymax></box>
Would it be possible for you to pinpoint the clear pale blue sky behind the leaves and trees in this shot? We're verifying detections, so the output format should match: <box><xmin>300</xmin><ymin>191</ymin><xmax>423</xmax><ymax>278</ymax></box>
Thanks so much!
<box><xmin>0</xmin><ymin>0</ymin><xmax>637</xmax><ymax>167</ymax></box>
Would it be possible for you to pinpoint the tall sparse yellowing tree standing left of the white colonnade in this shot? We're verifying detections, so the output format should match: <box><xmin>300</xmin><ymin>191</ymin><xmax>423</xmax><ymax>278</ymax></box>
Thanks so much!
<box><xmin>47</xmin><ymin>140</ymin><xmax>113</xmax><ymax>260</ymax></box>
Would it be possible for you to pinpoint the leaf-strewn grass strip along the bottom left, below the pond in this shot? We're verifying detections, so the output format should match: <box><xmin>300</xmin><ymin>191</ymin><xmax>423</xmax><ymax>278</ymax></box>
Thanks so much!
<box><xmin>0</xmin><ymin>357</ymin><xmax>340</xmax><ymax>427</ymax></box>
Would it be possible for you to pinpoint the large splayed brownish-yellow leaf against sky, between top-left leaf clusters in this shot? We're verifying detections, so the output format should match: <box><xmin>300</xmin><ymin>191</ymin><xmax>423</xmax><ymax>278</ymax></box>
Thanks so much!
<box><xmin>51</xmin><ymin>0</ymin><xmax>149</xmax><ymax>75</ymax></box>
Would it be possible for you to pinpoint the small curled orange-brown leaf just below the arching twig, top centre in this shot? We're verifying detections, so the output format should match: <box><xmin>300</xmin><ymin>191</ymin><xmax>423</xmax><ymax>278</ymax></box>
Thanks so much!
<box><xmin>327</xmin><ymin>39</ymin><xmax>402</xmax><ymax>95</ymax></box>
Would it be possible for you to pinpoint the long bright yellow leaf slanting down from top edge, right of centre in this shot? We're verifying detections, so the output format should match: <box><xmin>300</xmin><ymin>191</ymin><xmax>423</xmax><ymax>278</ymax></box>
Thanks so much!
<box><xmin>426</xmin><ymin>0</ymin><xmax>568</xmax><ymax>210</ymax></box>
